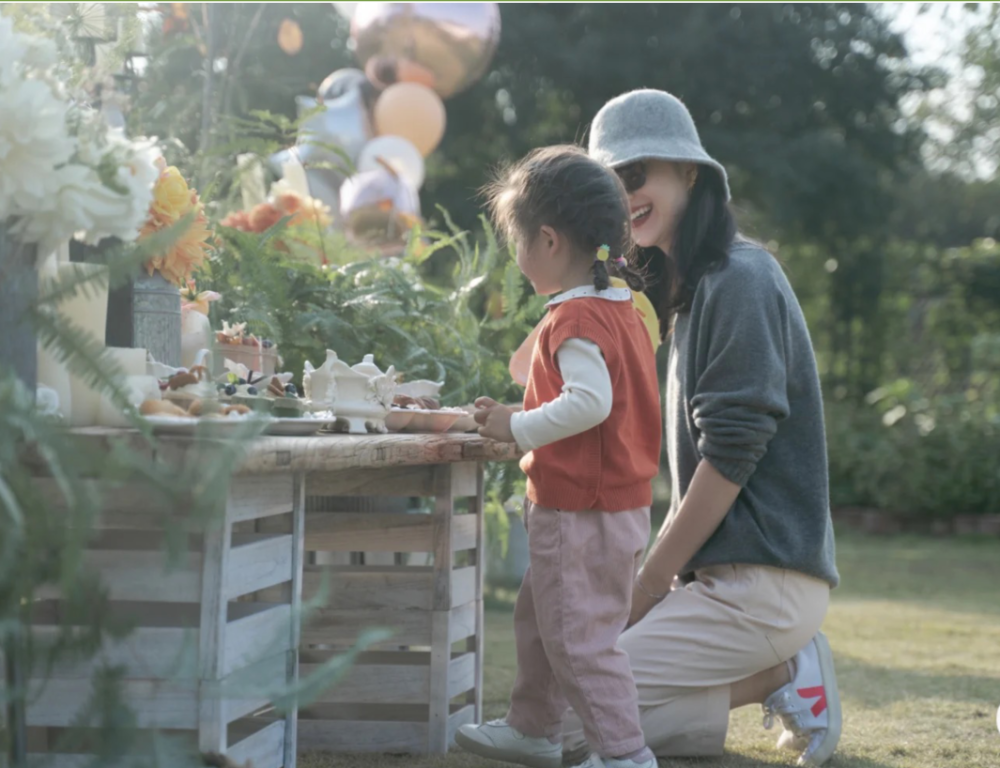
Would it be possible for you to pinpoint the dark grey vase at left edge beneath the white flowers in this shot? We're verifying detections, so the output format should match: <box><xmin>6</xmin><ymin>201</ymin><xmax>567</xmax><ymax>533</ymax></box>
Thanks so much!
<box><xmin>0</xmin><ymin>222</ymin><xmax>38</xmax><ymax>391</ymax></box>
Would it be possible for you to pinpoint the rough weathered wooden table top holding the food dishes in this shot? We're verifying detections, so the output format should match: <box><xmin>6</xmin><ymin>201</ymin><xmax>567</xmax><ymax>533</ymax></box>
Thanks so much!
<box><xmin>39</xmin><ymin>427</ymin><xmax>521</xmax><ymax>475</ymax></box>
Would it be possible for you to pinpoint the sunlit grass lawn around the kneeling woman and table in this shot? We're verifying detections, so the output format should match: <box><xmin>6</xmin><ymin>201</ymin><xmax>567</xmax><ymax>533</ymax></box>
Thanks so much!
<box><xmin>300</xmin><ymin>534</ymin><xmax>1000</xmax><ymax>768</ymax></box>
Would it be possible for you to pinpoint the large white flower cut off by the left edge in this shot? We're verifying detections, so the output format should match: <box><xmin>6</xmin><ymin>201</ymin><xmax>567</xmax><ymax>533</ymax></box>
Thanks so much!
<box><xmin>0</xmin><ymin>80</ymin><xmax>76</xmax><ymax>216</ymax></box>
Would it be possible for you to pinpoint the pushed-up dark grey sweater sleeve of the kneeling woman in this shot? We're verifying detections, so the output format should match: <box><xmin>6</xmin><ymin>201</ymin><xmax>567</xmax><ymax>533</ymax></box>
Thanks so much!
<box><xmin>691</xmin><ymin>255</ymin><xmax>789</xmax><ymax>486</ymax></box>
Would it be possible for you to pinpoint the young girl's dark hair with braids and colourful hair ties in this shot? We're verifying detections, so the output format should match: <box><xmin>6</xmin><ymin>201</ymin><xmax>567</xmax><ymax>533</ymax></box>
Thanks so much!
<box><xmin>483</xmin><ymin>145</ymin><xmax>645</xmax><ymax>291</ymax></box>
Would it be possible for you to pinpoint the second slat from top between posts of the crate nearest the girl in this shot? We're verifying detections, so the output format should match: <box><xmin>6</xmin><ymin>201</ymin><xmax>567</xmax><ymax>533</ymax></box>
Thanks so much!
<box><xmin>306</xmin><ymin>512</ymin><xmax>433</xmax><ymax>552</ymax></box>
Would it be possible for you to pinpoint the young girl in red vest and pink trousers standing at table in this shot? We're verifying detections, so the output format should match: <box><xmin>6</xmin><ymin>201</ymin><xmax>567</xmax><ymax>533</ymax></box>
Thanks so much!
<box><xmin>456</xmin><ymin>147</ymin><xmax>661</xmax><ymax>768</ymax></box>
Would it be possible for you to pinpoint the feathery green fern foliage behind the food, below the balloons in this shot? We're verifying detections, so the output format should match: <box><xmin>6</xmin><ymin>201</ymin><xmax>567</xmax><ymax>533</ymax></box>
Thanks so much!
<box><xmin>200</xmin><ymin>207</ymin><xmax>542</xmax><ymax>405</ymax></box>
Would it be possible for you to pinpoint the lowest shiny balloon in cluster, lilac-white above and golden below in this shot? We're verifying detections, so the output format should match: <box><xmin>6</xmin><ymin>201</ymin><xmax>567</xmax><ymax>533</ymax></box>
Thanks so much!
<box><xmin>340</xmin><ymin>168</ymin><xmax>420</xmax><ymax>244</ymax></box>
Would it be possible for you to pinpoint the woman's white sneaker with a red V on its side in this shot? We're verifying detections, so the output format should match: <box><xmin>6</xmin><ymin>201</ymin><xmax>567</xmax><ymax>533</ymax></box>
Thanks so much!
<box><xmin>763</xmin><ymin>632</ymin><xmax>842</xmax><ymax>765</ymax></box>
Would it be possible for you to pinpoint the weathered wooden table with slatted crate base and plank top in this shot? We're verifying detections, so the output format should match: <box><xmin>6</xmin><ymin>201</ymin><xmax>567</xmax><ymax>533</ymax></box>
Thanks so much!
<box><xmin>19</xmin><ymin>429</ymin><xmax>516</xmax><ymax>768</ymax></box>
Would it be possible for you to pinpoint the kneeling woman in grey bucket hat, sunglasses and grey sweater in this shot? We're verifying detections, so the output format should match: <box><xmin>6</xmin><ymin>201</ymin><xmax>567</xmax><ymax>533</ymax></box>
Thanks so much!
<box><xmin>564</xmin><ymin>90</ymin><xmax>841</xmax><ymax>765</ymax></box>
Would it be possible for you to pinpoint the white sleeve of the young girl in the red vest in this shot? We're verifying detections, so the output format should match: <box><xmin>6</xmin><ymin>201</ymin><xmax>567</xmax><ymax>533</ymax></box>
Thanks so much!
<box><xmin>510</xmin><ymin>338</ymin><xmax>612</xmax><ymax>451</ymax></box>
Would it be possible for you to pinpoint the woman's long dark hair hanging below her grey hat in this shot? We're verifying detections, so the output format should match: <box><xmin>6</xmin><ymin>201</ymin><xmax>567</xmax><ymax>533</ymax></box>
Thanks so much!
<box><xmin>636</xmin><ymin>166</ymin><xmax>737</xmax><ymax>338</ymax></box>
